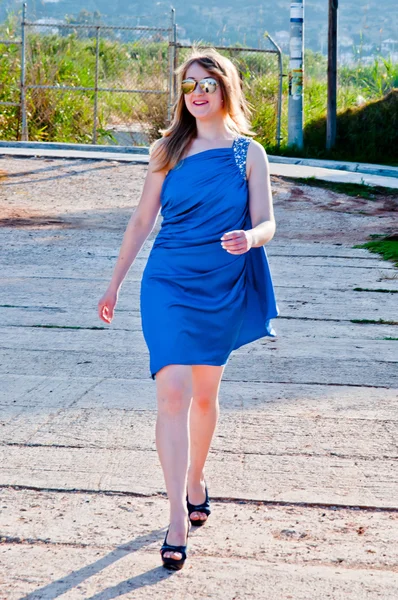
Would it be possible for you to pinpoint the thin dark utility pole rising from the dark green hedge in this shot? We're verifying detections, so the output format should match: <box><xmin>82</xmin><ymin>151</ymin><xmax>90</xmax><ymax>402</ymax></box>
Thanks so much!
<box><xmin>326</xmin><ymin>0</ymin><xmax>339</xmax><ymax>150</ymax></box>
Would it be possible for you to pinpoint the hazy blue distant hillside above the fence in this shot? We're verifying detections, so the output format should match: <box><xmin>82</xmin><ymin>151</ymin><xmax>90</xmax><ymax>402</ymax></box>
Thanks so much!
<box><xmin>0</xmin><ymin>0</ymin><xmax>398</xmax><ymax>54</ymax></box>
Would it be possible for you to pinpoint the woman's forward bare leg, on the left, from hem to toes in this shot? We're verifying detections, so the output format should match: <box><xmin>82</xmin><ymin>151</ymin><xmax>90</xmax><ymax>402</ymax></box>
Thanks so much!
<box><xmin>156</xmin><ymin>365</ymin><xmax>192</xmax><ymax>559</ymax></box>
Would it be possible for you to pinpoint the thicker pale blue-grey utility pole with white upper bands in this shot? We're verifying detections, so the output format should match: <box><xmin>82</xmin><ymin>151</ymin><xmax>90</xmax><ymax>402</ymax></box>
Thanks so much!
<box><xmin>288</xmin><ymin>0</ymin><xmax>304</xmax><ymax>148</ymax></box>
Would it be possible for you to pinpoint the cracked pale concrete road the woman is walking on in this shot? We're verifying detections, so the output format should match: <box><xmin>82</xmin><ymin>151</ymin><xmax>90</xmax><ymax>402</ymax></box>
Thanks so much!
<box><xmin>0</xmin><ymin>158</ymin><xmax>398</xmax><ymax>600</ymax></box>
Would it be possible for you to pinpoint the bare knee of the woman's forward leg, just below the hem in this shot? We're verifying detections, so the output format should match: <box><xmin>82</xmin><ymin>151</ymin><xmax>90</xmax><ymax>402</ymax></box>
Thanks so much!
<box><xmin>156</xmin><ymin>365</ymin><xmax>192</xmax><ymax>414</ymax></box>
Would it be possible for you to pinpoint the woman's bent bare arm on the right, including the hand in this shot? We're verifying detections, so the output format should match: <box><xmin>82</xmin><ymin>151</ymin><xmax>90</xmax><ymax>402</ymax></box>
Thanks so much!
<box><xmin>221</xmin><ymin>140</ymin><xmax>275</xmax><ymax>254</ymax></box>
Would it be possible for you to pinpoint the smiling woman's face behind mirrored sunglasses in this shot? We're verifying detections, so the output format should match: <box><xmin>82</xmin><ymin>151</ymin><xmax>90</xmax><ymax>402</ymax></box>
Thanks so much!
<box><xmin>184</xmin><ymin>63</ymin><xmax>223</xmax><ymax>119</ymax></box>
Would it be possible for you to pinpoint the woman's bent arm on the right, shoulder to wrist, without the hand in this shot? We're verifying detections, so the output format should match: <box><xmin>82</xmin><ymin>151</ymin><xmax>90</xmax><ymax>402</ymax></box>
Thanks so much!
<box><xmin>246</xmin><ymin>140</ymin><xmax>276</xmax><ymax>248</ymax></box>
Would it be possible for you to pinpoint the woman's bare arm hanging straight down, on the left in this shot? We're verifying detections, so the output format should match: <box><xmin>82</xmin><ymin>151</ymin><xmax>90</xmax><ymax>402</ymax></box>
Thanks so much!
<box><xmin>98</xmin><ymin>144</ymin><xmax>166</xmax><ymax>323</ymax></box>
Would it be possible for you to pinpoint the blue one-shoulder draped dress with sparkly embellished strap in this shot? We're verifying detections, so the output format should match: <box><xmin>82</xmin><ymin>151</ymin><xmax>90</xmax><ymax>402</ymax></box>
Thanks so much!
<box><xmin>140</xmin><ymin>136</ymin><xmax>279</xmax><ymax>379</ymax></box>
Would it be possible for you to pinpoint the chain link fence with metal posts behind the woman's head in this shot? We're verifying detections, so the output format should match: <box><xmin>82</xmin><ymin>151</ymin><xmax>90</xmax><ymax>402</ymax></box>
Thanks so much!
<box><xmin>0</xmin><ymin>5</ymin><xmax>283</xmax><ymax>145</ymax></box>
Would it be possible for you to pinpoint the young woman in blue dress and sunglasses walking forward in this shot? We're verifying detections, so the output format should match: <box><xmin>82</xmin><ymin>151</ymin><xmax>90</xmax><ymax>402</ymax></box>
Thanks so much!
<box><xmin>98</xmin><ymin>49</ymin><xmax>278</xmax><ymax>569</ymax></box>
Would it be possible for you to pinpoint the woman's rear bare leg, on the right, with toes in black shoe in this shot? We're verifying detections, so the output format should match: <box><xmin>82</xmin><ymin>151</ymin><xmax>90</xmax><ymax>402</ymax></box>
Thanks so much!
<box><xmin>187</xmin><ymin>365</ymin><xmax>225</xmax><ymax>520</ymax></box>
